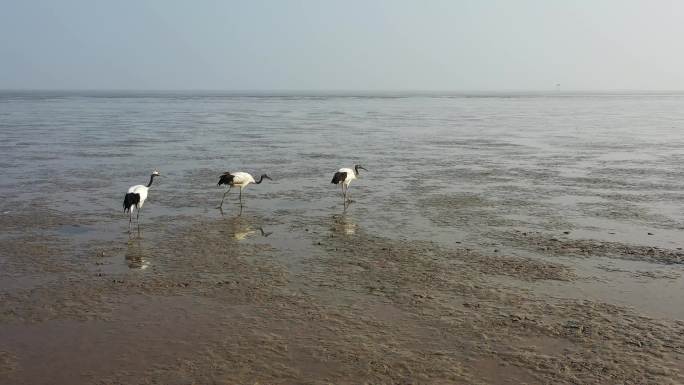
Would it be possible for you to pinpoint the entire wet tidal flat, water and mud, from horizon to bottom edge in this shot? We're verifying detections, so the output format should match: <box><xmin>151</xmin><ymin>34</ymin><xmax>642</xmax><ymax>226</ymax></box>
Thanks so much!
<box><xmin>0</xmin><ymin>94</ymin><xmax>684</xmax><ymax>384</ymax></box>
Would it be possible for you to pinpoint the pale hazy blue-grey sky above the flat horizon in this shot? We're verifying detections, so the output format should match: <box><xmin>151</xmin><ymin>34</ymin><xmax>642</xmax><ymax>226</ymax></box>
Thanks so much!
<box><xmin>0</xmin><ymin>0</ymin><xmax>684</xmax><ymax>91</ymax></box>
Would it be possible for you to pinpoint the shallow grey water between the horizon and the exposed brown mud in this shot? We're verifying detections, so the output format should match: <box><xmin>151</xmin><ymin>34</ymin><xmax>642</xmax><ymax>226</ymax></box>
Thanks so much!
<box><xmin>0</xmin><ymin>92</ymin><xmax>684</xmax><ymax>382</ymax></box>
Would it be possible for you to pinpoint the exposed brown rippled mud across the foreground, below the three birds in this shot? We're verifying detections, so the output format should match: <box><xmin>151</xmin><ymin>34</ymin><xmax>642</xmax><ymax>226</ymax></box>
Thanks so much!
<box><xmin>0</xmin><ymin>204</ymin><xmax>684</xmax><ymax>384</ymax></box>
